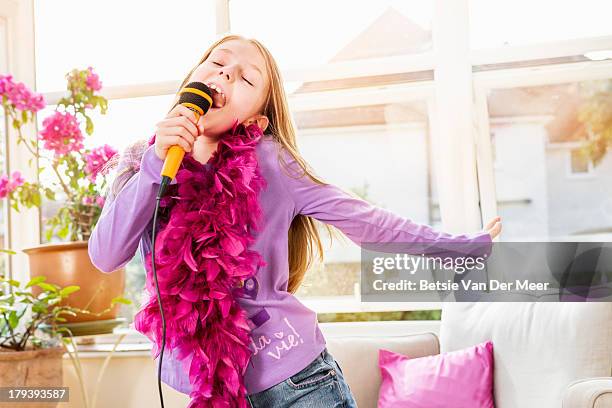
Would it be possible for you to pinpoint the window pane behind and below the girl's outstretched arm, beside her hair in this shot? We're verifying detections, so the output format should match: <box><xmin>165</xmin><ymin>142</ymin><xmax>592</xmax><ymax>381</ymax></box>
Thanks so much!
<box><xmin>294</xmin><ymin>96</ymin><xmax>440</xmax><ymax>297</ymax></box>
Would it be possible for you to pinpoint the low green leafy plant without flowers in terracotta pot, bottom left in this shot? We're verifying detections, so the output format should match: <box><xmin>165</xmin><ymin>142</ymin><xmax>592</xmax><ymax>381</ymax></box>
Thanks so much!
<box><xmin>0</xmin><ymin>262</ymin><xmax>126</xmax><ymax>408</ymax></box>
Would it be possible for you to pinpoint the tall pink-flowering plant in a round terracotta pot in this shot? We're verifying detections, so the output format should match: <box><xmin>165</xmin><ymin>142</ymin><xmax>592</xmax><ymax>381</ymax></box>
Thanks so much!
<box><xmin>0</xmin><ymin>67</ymin><xmax>125</xmax><ymax>330</ymax></box>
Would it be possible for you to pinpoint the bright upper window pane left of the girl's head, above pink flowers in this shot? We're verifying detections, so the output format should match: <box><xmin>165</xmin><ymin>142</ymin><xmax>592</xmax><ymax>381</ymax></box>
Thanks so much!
<box><xmin>35</xmin><ymin>0</ymin><xmax>215</xmax><ymax>92</ymax></box>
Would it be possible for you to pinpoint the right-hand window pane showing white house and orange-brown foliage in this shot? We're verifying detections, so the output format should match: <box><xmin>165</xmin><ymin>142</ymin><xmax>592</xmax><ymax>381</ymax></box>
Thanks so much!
<box><xmin>488</xmin><ymin>80</ymin><xmax>612</xmax><ymax>241</ymax></box>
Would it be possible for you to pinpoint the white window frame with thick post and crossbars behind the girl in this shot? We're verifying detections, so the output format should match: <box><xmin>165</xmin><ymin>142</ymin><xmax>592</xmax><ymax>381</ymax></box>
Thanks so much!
<box><xmin>23</xmin><ymin>0</ymin><xmax>612</xmax><ymax>312</ymax></box>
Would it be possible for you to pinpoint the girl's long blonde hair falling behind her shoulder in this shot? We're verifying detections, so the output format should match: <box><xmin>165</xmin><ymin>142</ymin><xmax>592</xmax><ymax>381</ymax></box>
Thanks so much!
<box><xmin>172</xmin><ymin>34</ymin><xmax>334</xmax><ymax>293</ymax></box>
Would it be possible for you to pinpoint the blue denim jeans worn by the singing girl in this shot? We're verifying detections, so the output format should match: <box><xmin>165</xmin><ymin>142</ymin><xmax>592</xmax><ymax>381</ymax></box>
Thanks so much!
<box><xmin>247</xmin><ymin>348</ymin><xmax>357</xmax><ymax>408</ymax></box>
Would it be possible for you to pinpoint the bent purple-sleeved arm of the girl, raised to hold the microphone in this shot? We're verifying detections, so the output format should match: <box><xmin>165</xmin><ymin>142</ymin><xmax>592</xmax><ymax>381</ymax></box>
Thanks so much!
<box><xmin>88</xmin><ymin>145</ymin><xmax>176</xmax><ymax>272</ymax></box>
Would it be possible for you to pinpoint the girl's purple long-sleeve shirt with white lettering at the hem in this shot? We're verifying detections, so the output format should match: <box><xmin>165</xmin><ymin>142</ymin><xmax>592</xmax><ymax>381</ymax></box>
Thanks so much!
<box><xmin>89</xmin><ymin>135</ymin><xmax>491</xmax><ymax>394</ymax></box>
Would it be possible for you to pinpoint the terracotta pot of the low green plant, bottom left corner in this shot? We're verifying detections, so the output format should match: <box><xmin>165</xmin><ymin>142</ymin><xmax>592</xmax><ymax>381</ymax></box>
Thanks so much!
<box><xmin>0</xmin><ymin>346</ymin><xmax>65</xmax><ymax>408</ymax></box>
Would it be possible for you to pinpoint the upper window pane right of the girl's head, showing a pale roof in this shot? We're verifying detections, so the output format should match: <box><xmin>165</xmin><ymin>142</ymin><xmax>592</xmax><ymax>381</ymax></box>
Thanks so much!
<box><xmin>230</xmin><ymin>0</ymin><xmax>432</xmax><ymax>70</ymax></box>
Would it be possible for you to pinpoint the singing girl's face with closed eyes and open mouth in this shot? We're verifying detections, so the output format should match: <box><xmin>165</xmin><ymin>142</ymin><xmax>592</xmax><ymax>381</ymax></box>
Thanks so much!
<box><xmin>187</xmin><ymin>40</ymin><xmax>269</xmax><ymax>138</ymax></box>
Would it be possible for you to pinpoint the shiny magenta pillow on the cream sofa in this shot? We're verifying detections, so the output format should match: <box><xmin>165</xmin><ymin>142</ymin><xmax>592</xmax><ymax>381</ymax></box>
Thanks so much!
<box><xmin>378</xmin><ymin>341</ymin><xmax>495</xmax><ymax>408</ymax></box>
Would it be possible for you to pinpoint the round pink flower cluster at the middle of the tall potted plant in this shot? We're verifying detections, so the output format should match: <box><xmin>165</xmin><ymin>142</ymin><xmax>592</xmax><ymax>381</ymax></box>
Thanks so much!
<box><xmin>40</xmin><ymin>112</ymin><xmax>83</xmax><ymax>156</ymax></box>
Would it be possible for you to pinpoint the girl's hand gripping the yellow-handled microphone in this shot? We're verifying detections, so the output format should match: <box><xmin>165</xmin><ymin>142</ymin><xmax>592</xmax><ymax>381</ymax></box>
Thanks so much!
<box><xmin>155</xmin><ymin>105</ymin><xmax>199</xmax><ymax>160</ymax></box>
